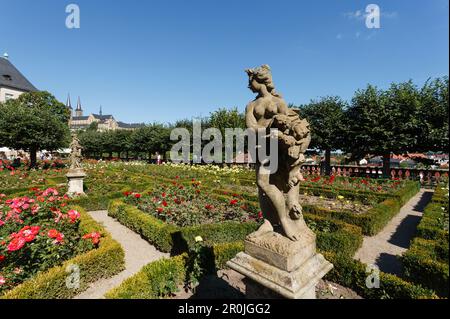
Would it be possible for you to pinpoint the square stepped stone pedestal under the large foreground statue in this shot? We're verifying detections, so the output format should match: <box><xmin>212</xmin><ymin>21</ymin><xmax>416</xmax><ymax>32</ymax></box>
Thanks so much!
<box><xmin>227</xmin><ymin>229</ymin><xmax>333</xmax><ymax>299</ymax></box>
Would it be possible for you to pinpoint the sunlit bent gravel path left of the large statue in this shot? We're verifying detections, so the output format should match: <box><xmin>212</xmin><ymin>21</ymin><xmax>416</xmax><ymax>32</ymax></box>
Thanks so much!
<box><xmin>75</xmin><ymin>211</ymin><xmax>169</xmax><ymax>299</ymax></box>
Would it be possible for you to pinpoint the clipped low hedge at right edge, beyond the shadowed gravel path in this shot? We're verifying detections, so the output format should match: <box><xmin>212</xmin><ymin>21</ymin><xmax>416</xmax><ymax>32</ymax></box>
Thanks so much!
<box><xmin>402</xmin><ymin>186</ymin><xmax>449</xmax><ymax>297</ymax></box>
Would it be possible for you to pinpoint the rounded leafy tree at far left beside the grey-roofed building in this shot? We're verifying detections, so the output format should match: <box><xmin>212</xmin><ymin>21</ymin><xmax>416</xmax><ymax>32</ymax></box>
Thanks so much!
<box><xmin>0</xmin><ymin>92</ymin><xmax>70</xmax><ymax>168</ymax></box>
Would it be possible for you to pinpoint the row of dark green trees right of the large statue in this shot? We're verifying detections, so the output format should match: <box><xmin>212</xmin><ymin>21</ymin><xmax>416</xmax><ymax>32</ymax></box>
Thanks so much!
<box><xmin>299</xmin><ymin>77</ymin><xmax>449</xmax><ymax>176</ymax></box>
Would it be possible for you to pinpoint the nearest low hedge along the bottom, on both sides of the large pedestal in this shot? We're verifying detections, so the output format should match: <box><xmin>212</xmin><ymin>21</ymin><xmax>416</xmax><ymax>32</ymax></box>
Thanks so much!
<box><xmin>105</xmin><ymin>241</ymin><xmax>437</xmax><ymax>299</ymax></box>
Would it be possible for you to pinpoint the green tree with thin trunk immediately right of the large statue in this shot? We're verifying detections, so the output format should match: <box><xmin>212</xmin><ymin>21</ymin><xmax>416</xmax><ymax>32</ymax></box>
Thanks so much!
<box><xmin>300</xmin><ymin>96</ymin><xmax>347</xmax><ymax>175</ymax></box>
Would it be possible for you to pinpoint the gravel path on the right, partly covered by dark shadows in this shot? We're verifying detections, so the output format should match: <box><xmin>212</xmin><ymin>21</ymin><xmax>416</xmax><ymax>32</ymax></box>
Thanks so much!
<box><xmin>354</xmin><ymin>189</ymin><xmax>433</xmax><ymax>275</ymax></box>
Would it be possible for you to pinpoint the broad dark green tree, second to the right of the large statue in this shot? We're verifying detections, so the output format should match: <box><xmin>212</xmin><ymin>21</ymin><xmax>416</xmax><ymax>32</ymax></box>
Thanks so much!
<box><xmin>344</xmin><ymin>81</ymin><xmax>420</xmax><ymax>177</ymax></box>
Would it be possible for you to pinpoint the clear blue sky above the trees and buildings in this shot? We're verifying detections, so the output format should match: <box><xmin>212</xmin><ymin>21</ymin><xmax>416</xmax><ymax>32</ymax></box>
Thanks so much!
<box><xmin>0</xmin><ymin>0</ymin><xmax>449</xmax><ymax>122</ymax></box>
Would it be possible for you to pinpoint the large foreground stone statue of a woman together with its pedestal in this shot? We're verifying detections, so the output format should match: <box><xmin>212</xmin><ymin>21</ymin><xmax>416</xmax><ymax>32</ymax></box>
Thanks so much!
<box><xmin>228</xmin><ymin>65</ymin><xmax>333</xmax><ymax>299</ymax></box>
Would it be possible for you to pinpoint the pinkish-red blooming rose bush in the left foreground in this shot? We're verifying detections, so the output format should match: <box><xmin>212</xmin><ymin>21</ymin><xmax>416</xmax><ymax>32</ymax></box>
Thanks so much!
<box><xmin>0</xmin><ymin>188</ymin><xmax>100</xmax><ymax>294</ymax></box>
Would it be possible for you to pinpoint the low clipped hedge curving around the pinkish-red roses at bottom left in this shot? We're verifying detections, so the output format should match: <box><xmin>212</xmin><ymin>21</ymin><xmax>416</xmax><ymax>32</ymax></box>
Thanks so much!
<box><xmin>0</xmin><ymin>206</ymin><xmax>125</xmax><ymax>299</ymax></box>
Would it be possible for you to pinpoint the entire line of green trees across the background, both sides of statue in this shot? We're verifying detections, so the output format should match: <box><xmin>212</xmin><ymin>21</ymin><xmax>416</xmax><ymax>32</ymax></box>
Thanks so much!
<box><xmin>0</xmin><ymin>77</ymin><xmax>449</xmax><ymax>174</ymax></box>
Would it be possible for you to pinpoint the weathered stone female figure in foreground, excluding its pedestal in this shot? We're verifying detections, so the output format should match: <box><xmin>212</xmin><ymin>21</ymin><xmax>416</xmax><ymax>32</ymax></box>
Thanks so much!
<box><xmin>246</xmin><ymin>65</ymin><xmax>311</xmax><ymax>241</ymax></box>
